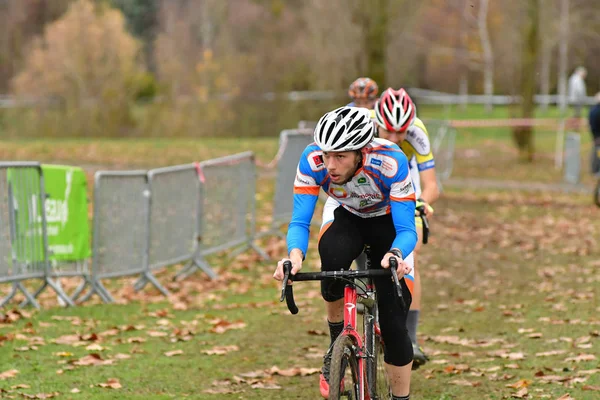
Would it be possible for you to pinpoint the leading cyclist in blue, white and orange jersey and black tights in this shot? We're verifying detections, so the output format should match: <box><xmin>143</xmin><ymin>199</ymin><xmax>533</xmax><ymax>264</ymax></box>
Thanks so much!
<box><xmin>273</xmin><ymin>107</ymin><xmax>417</xmax><ymax>400</ymax></box>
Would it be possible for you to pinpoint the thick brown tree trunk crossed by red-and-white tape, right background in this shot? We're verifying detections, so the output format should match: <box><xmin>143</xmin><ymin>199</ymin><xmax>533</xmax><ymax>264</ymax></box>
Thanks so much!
<box><xmin>513</xmin><ymin>0</ymin><xmax>540</xmax><ymax>162</ymax></box>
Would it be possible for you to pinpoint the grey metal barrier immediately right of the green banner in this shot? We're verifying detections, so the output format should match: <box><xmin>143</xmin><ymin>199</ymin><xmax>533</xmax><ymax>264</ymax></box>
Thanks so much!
<box><xmin>74</xmin><ymin>171</ymin><xmax>169</xmax><ymax>302</ymax></box>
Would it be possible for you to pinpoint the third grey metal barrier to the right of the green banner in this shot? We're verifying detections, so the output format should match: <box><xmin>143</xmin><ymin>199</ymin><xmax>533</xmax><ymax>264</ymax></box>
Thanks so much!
<box><xmin>178</xmin><ymin>151</ymin><xmax>269</xmax><ymax>278</ymax></box>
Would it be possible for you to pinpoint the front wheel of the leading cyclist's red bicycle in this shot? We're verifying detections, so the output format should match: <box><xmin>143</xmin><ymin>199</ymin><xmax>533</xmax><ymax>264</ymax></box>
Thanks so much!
<box><xmin>329</xmin><ymin>335</ymin><xmax>361</xmax><ymax>400</ymax></box>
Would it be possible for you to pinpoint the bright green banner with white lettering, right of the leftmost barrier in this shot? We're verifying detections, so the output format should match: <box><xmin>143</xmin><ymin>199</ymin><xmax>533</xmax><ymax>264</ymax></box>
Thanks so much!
<box><xmin>42</xmin><ymin>165</ymin><xmax>92</xmax><ymax>261</ymax></box>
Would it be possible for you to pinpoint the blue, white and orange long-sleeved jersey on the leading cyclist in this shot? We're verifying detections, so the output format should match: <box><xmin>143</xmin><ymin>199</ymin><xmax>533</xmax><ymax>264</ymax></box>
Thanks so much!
<box><xmin>287</xmin><ymin>139</ymin><xmax>417</xmax><ymax>255</ymax></box>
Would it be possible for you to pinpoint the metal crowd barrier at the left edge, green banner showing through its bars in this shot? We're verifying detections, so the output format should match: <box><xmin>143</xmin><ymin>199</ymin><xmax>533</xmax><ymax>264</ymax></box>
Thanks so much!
<box><xmin>0</xmin><ymin>162</ymin><xmax>74</xmax><ymax>308</ymax></box>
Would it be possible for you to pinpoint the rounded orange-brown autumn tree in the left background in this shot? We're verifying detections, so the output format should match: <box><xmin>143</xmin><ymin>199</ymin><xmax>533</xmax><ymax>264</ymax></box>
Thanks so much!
<box><xmin>13</xmin><ymin>0</ymin><xmax>142</xmax><ymax>136</ymax></box>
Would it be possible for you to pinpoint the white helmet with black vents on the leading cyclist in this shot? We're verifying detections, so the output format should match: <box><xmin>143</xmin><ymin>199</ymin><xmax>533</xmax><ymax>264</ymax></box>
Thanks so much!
<box><xmin>315</xmin><ymin>107</ymin><xmax>375</xmax><ymax>151</ymax></box>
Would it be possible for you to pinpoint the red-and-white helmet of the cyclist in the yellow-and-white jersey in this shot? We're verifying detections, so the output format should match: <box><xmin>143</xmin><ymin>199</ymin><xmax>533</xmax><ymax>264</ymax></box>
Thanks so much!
<box><xmin>375</xmin><ymin>88</ymin><xmax>417</xmax><ymax>132</ymax></box>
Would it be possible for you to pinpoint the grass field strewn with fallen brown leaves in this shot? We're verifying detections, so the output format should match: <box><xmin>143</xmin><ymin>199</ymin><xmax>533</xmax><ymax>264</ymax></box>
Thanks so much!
<box><xmin>0</xmin><ymin>108</ymin><xmax>600</xmax><ymax>400</ymax></box>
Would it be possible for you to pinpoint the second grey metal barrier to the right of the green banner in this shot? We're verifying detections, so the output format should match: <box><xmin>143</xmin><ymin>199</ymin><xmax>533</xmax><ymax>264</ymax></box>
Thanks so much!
<box><xmin>136</xmin><ymin>164</ymin><xmax>217</xmax><ymax>290</ymax></box>
